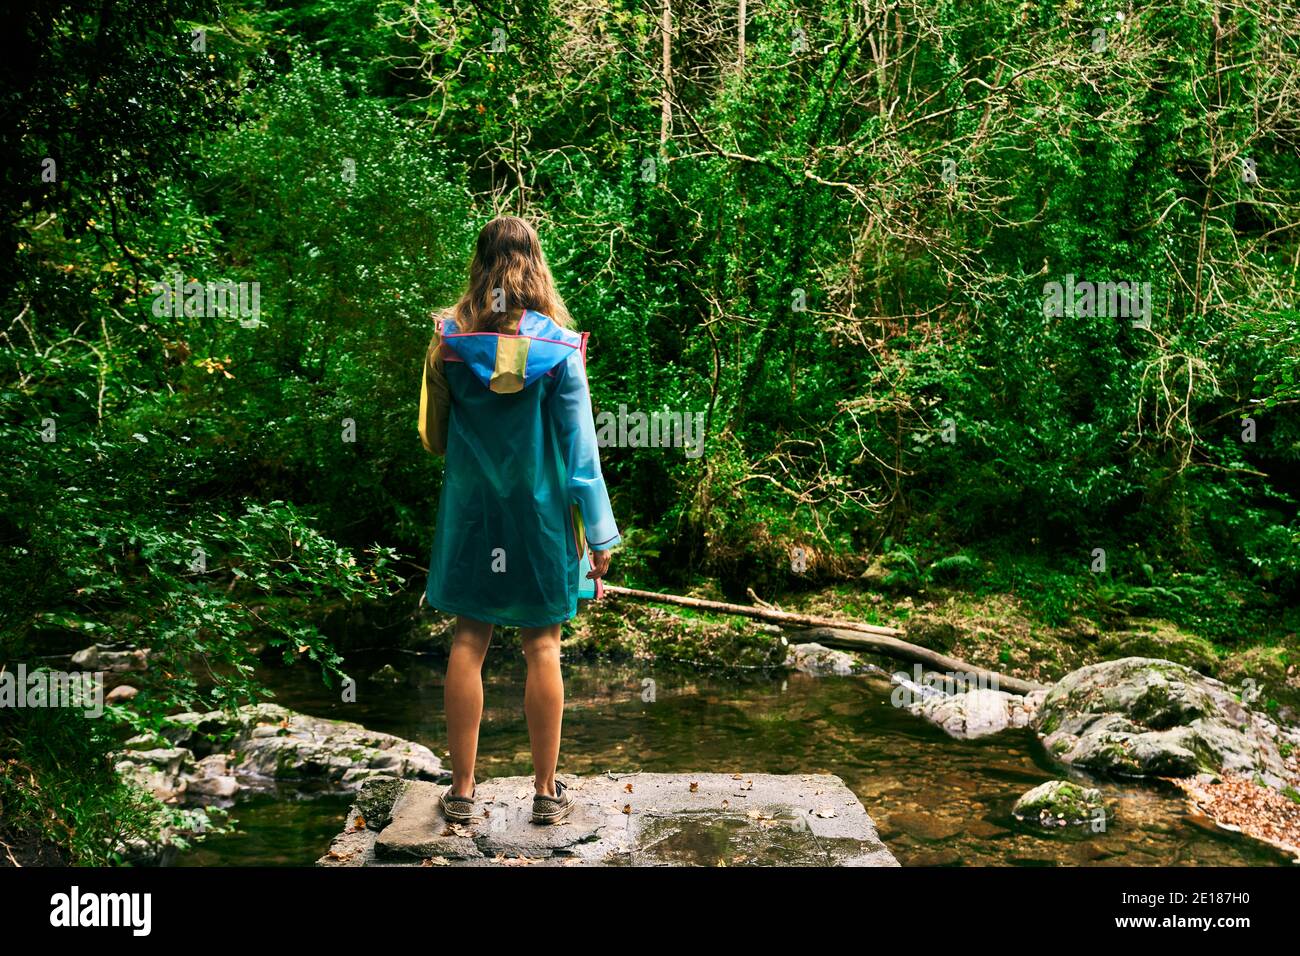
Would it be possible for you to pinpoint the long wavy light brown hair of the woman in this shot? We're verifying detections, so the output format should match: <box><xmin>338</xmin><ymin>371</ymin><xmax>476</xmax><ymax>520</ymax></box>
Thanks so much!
<box><xmin>451</xmin><ymin>216</ymin><xmax>573</xmax><ymax>332</ymax></box>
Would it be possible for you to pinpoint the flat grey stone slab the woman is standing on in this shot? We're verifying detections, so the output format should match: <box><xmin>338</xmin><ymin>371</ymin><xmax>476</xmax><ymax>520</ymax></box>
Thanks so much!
<box><xmin>319</xmin><ymin>774</ymin><xmax>898</xmax><ymax>866</ymax></box>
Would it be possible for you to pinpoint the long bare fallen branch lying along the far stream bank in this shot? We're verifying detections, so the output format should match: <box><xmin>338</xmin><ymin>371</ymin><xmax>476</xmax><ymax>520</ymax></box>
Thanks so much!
<box><xmin>605</xmin><ymin>584</ymin><xmax>1045</xmax><ymax>693</ymax></box>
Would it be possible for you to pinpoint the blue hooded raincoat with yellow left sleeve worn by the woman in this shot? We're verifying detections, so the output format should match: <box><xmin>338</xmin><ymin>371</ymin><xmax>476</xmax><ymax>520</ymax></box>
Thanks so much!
<box><xmin>420</xmin><ymin>310</ymin><xmax>620</xmax><ymax>627</ymax></box>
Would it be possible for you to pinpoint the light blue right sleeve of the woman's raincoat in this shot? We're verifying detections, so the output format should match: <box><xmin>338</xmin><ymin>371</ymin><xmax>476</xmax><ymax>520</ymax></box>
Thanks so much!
<box><xmin>551</xmin><ymin>351</ymin><xmax>623</xmax><ymax>551</ymax></box>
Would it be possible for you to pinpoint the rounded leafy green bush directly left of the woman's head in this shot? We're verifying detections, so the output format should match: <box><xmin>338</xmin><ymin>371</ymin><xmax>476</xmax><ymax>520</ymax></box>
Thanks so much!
<box><xmin>195</xmin><ymin>59</ymin><xmax>476</xmax><ymax>550</ymax></box>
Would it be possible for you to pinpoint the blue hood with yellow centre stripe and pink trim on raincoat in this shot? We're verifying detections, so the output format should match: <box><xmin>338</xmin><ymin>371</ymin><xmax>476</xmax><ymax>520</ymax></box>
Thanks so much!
<box><xmin>438</xmin><ymin>310</ymin><xmax>586</xmax><ymax>393</ymax></box>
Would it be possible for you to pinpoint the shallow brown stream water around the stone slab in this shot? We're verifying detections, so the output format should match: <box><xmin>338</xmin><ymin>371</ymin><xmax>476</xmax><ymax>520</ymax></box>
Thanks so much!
<box><xmin>177</xmin><ymin>648</ymin><xmax>1281</xmax><ymax>866</ymax></box>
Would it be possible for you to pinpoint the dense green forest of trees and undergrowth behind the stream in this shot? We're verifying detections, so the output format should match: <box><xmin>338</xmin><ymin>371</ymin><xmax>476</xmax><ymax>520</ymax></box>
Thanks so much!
<box><xmin>0</xmin><ymin>0</ymin><xmax>1300</xmax><ymax>864</ymax></box>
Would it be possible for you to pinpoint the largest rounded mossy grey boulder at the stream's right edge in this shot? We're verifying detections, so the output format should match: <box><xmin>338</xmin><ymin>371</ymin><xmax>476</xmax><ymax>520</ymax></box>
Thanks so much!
<box><xmin>1034</xmin><ymin>657</ymin><xmax>1287</xmax><ymax>786</ymax></box>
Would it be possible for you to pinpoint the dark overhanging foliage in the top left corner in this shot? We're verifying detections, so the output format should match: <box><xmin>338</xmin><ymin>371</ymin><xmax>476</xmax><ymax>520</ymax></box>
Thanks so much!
<box><xmin>0</xmin><ymin>0</ymin><xmax>250</xmax><ymax>284</ymax></box>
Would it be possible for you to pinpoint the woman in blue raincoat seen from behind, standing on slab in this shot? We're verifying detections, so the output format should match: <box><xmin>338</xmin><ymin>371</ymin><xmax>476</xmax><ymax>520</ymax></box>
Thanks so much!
<box><xmin>420</xmin><ymin>216</ymin><xmax>620</xmax><ymax>823</ymax></box>
